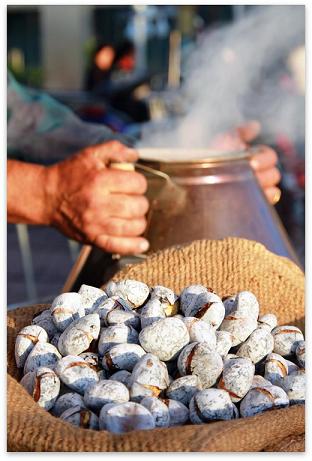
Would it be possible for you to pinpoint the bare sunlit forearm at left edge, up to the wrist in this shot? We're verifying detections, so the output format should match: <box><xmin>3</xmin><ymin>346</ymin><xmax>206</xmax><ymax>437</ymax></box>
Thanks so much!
<box><xmin>7</xmin><ymin>160</ymin><xmax>52</xmax><ymax>225</ymax></box>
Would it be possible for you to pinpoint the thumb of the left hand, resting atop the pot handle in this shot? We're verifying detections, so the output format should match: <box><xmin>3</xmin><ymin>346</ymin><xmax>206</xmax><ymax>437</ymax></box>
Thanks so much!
<box><xmin>88</xmin><ymin>141</ymin><xmax>139</xmax><ymax>166</ymax></box>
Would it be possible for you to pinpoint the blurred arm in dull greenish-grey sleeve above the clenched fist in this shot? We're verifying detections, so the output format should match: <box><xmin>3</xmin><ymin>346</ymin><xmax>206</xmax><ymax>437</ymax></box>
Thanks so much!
<box><xmin>7</xmin><ymin>71</ymin><xmax>134</xmax><ymax>164</ymax></box>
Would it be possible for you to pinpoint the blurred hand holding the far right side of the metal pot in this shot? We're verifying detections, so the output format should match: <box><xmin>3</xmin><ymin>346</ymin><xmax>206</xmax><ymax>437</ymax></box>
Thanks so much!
<box><xmin>213</xmin><ymin>121</ymin><xmax>281</xmax><ymax>205</ymax></box>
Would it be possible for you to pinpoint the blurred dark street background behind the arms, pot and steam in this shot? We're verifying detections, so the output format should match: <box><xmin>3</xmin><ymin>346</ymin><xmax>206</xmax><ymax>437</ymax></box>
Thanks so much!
<box><xmin>7</xmin><ymin>5</ymin><xmax>305</xmax><ymax>308</ymax></box>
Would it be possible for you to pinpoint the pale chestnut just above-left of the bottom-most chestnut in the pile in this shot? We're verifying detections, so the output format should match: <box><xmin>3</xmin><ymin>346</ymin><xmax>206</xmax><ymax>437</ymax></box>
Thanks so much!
<box><xmin>83</xmin><ymin>379</ymin><xmax>129</xmax><ymax>412</ymax></box>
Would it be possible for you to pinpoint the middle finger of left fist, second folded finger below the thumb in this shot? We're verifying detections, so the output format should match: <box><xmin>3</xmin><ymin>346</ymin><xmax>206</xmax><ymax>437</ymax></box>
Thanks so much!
<box><xmin>104</xmin><ymin>194</ymin><xmax>149</xmax><ymax>219</ymax></box>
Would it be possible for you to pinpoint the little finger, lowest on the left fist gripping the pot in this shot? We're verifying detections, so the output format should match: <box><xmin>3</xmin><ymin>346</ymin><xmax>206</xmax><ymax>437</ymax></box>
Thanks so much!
<box><xmin>93</xmin><ymin>235</ymin><xmax>149</xmax><ymax>255</ymax></box>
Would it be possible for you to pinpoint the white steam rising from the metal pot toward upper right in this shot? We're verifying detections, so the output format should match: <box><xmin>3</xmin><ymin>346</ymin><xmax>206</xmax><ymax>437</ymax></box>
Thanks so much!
<box><xmin>139</xmin><ymin>6</ymin><xmax>305</xmax><ymax>153</ymax></box>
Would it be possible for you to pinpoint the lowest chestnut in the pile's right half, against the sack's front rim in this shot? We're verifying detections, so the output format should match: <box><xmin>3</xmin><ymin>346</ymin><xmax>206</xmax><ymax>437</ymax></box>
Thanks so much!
<box><xmin>190</xmin><ymin>388</ymin><xmax>237</xmax><ymax>424</ymax></box>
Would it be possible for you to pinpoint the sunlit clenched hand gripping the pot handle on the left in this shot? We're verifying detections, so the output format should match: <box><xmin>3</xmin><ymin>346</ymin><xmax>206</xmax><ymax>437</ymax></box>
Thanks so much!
<box><xmin>46</xmin><ymin>141</ymin><xmax>148</xmax><ymax>254</ymax></box>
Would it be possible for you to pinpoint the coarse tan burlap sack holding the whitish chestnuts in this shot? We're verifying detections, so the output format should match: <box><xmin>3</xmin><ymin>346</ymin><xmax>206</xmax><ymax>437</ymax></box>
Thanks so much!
<box><xmin>7</xmin><ymin>238</ymin><xmax>304</xmax><ymax>452</ymax></box>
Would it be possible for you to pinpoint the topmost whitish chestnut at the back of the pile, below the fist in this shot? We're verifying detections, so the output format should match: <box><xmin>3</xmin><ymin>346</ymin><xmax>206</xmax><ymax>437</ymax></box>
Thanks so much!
<box><xmin>105</xmin><ymin>280</ymin><xmax>150</xmax><ymax>309</ymax></box>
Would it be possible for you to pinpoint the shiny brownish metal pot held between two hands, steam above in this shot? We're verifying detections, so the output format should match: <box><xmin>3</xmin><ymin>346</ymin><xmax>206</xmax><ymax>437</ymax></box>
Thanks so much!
<box><xmin>140</xmin><ymin>150</ymin><xmax>298</xmax><ymax>263</ymax></box>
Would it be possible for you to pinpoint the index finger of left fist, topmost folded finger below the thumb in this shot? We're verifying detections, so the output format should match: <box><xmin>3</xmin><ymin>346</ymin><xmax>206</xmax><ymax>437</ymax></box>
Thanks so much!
<box><xmin>94</xmin><ymin>168</ymin><xmax>147</xmax><ymax>195</ymax></box>
